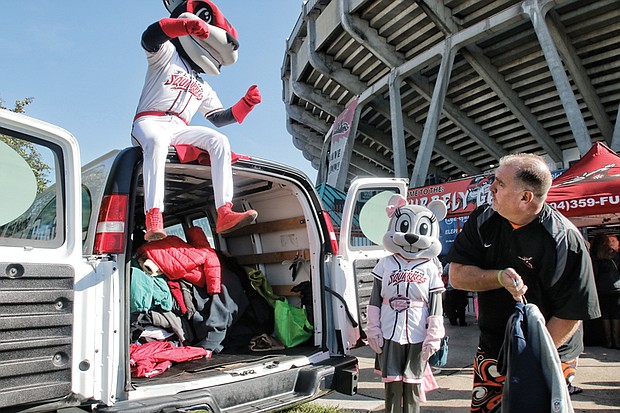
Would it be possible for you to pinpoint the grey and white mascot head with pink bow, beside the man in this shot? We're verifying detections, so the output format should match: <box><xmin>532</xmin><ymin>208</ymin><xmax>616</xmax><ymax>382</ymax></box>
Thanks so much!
<box><xmin>383</xmin><ymin>195</ymin><xmax>448</xmax><ymax>259</ymax></box>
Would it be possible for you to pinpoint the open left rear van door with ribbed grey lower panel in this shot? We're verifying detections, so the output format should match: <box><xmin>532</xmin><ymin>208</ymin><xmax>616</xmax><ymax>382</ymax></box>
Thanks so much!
<box><xmin>0</xmin><ymin>110</ymin><xmax>86</xmax><ymax>410</ymax></box>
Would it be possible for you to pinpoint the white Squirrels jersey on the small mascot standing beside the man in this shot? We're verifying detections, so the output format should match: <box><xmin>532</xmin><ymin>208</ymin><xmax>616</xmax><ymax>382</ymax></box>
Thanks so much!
<box><xmin>372</xmin><ymin>254</ymin><xmax>444</xmax><ymax>344</ymax></box>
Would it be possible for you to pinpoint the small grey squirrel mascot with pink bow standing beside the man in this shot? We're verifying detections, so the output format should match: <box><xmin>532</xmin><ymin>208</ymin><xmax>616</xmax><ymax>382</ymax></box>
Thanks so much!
<box><xmin>366</xmin><ymin>194</ymin><xmax>447</xmax><ymax>413</ymax></box>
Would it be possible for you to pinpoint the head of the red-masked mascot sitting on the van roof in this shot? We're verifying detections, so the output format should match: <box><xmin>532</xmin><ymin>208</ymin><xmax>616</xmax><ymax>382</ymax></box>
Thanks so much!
<box><xmin>163</xmin><ymin>0</ymin><xmax>239</xmax><ymax>75</ymax></box>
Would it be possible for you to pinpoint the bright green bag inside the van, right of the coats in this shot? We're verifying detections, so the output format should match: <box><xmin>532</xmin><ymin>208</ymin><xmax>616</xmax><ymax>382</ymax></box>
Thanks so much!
<box><xmin>273</xmin><ymin>298</ymin><xmax>314</xmax><ymax>348</ymax></box>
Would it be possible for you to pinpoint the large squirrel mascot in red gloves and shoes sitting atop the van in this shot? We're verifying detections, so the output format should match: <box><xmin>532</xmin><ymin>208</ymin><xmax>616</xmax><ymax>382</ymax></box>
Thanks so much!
<box><xmin>131</xmin><ymin>0</ymin><xmax>261</xmax><ymax>241</ymax></box>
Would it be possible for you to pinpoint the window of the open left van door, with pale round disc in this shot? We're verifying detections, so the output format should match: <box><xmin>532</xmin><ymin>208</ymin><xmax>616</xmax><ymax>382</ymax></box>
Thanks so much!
<box><xmin>0</xmin><ymin>129</ymin><xmax>65</xmax><ymax>248</ymax></box>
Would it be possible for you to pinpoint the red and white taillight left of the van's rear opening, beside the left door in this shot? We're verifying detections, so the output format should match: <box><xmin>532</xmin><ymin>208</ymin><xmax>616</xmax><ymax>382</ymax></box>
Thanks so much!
<box><xmin>93</xmin><ymin>195</ymin><xmax>127</xmax><ymax>254</ymax></box>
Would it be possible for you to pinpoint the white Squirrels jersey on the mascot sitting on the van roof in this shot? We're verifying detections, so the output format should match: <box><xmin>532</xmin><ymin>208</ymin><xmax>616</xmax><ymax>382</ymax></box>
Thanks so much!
<box><xmin>137</xmin><ymin>41</ymin><xmax>222</xmax><ymax>124</ymax></box>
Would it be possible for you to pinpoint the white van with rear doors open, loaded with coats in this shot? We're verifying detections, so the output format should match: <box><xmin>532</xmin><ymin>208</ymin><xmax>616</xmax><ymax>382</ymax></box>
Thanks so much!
<box><xmin>0</xmin><ymin>110</ymin><xmax>407</xmax><ymax>412</ymax></box>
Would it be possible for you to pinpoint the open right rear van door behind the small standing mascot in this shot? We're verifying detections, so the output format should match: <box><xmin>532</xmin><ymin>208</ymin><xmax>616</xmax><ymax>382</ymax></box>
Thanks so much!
<box><xmin>332</xmin><ymin>178</ymin><xmax>408</xmax><ymax>350</ymax></box>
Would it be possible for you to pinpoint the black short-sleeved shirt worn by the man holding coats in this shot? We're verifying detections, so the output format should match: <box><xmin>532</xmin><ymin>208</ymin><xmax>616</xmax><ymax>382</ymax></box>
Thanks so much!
<box><xmin>447</xmin><ymin>204</ymin><xmax>600</xmax><ymax>361</ymax></box>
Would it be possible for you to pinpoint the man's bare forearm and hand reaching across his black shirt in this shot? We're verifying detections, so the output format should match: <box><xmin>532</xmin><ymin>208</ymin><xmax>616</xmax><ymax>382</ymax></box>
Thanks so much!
<box><xmin>450</xmin><ymin>262</ymin><xmax>527</xmax><ymax>301</ymax></box>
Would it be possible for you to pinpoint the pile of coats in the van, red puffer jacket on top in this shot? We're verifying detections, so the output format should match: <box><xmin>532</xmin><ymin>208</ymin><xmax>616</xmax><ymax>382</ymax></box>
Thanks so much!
<box><xmin>130</xmin><ymin>227</ymin><xmax>273</xmax><ymax>376</ymax></box>
